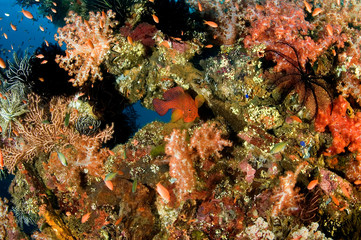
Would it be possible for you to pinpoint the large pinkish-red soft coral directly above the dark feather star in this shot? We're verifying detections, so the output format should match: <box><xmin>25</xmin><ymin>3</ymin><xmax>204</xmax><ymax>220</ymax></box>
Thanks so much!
<box><xmin>244</xmin><ymin>1</ymin><xmax>347</xmax><ymax>72</ymax></box>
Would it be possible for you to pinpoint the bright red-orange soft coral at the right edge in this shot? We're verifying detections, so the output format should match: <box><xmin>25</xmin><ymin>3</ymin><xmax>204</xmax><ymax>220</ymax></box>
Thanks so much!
<box><xmin>315</xmin><ymin>96</ymin><xmax>361</xmax><ymax>161</ymax></box>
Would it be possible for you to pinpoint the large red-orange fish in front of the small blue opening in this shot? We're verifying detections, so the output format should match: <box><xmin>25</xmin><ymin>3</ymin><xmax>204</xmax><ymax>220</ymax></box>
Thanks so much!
<box><xmin>153</xmin><ymin>86</ymin><xmax>199</xmax><ymax>122</ymax></box>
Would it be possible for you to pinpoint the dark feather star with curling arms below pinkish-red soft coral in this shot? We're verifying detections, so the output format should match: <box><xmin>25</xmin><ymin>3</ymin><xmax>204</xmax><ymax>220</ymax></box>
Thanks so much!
<box><xmin>265</xmin><ymin>42</ymin><xmax>332</xmax><ymax>120</ymax></box>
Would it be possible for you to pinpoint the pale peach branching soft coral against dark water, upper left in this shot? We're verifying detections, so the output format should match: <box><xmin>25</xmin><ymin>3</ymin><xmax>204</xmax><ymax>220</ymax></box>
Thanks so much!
<box><xmin>54</xmin><ymin>10</ymin><xmax>117</xmax><ymax>86</ymax></box>
